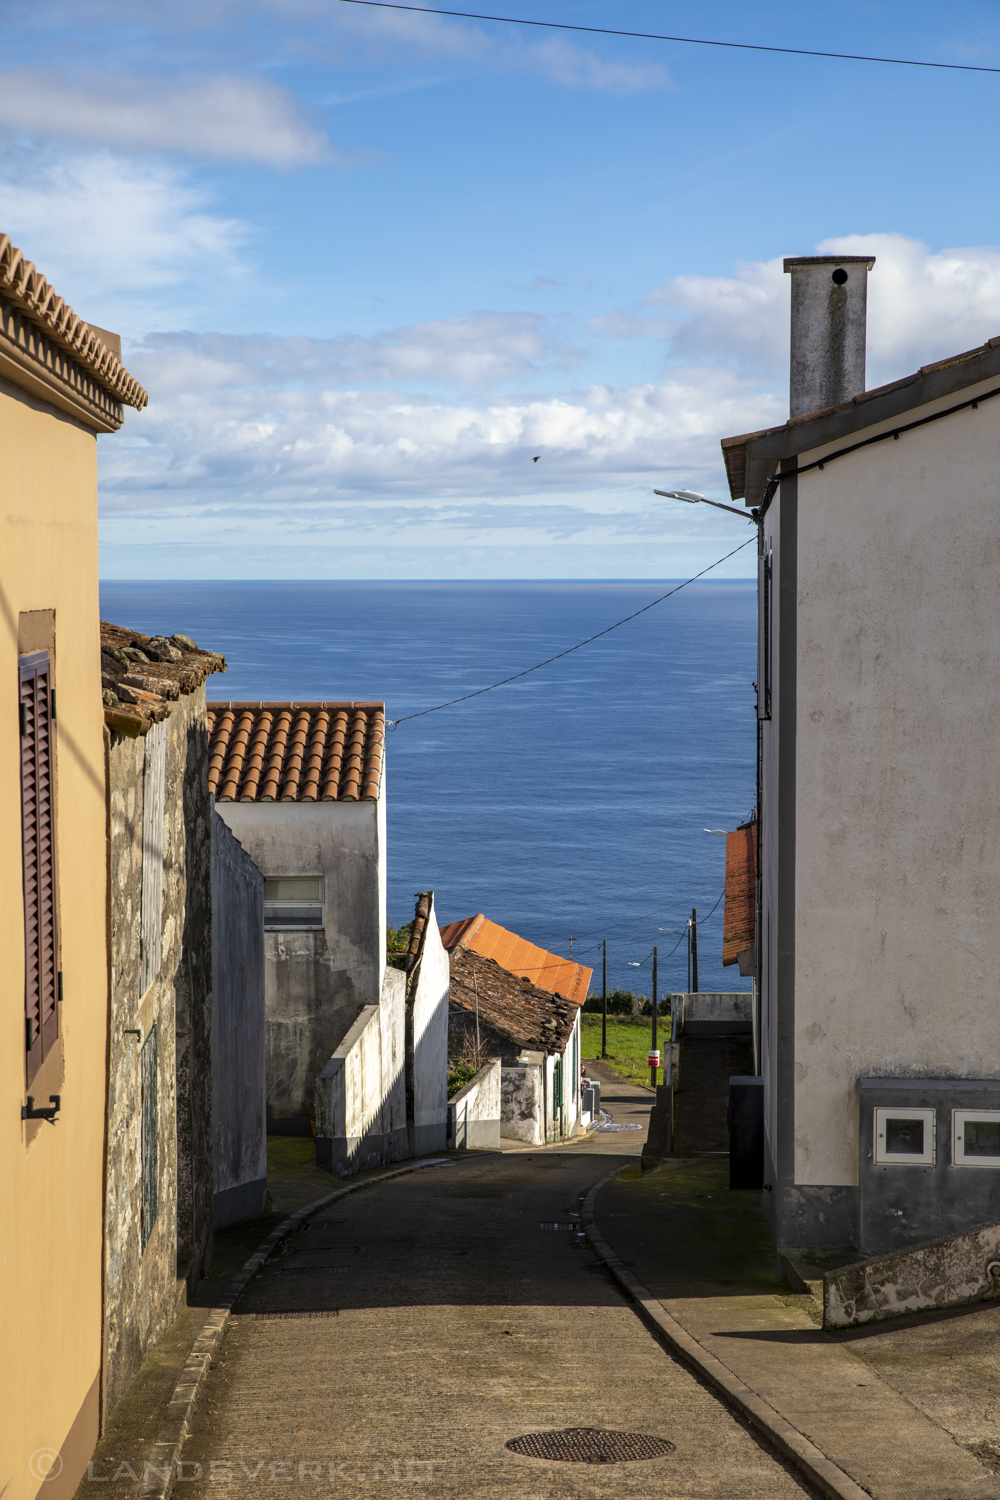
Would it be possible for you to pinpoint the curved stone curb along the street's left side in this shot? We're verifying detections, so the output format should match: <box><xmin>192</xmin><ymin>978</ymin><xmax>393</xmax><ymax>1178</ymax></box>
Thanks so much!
<box><xmin>139</xmin><ymin>1157</ymin><xmax>460</xmax><ymax>1500</ymax></box>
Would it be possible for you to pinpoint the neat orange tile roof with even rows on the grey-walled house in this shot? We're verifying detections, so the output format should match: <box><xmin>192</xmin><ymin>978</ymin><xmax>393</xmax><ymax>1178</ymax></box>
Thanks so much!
<box><xmin>208</xmin><ymin>704</ymin><xmax>385</xmax><ymax>803</ymax></box>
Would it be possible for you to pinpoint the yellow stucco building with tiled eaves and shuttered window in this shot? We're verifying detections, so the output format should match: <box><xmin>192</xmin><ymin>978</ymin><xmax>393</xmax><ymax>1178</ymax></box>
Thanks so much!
<box><xmin>0</xmin><ymin>236</ymin><xmax>147</xmax><ymax>1500</ymax></box>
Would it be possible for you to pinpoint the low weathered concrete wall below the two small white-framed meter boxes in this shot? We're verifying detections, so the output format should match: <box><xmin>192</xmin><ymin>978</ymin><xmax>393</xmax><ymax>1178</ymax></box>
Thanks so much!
<box><xmin>823</xmin><ymin>1224</ymin><xmax>1000</xmax><ymax>1328</ymax></box>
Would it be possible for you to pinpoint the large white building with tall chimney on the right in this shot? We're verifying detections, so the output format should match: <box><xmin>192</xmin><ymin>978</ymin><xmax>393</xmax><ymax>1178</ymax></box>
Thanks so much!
<box><xmin>723</xmin><ymin>257</ymin><xmax>1000</xmax><ymax>1251</ymax></box>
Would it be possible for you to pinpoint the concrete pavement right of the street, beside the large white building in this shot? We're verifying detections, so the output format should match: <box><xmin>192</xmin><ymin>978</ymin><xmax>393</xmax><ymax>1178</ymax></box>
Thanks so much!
<box><xmin>595</xmin><ymin>1157</ymin><xmax>1000</xmax><ymax>1500</ymax></box>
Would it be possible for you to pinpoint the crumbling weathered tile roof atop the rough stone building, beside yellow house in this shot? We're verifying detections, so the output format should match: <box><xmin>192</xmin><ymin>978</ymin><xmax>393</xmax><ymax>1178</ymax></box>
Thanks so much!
<box><xmin>100</xmin><ymin>620</ymin><xmax>226</xmax><ymax>738</ymax></box>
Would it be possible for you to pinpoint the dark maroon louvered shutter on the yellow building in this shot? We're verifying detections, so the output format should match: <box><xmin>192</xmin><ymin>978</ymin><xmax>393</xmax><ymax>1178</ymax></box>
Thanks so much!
<box><xmin>18</xmin><ymin>651</ymin><xmax>61</xmax><ymax>1083</ymax></box>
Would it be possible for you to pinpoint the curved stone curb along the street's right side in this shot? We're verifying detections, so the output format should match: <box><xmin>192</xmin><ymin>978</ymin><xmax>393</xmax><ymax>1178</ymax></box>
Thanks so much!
<box><xmin>582</xmin><ymin>1167</ymin><xmax>871</xmax><ymax>1500</ymax></box>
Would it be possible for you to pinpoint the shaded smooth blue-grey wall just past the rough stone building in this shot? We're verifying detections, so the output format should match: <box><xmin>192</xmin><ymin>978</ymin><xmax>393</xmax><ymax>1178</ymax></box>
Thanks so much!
<box><xmin>211</xmin><ymin>813</ymin><xmax>267</xmax><ymax>1229</ymax></box>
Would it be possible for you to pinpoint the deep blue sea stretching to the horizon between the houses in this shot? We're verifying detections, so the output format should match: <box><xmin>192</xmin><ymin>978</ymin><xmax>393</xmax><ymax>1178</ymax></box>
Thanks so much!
<box><xmin>100</xmin><ymin>581</ymin><xmax>756</xmax><ymax>995</ymax></box>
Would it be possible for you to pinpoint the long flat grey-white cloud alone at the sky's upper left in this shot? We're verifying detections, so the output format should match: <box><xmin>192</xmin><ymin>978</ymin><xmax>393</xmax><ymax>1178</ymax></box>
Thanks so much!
<box><xmin>0</xmin><ymin>68</ymin><xmax>336</xmax><ymax>167</ymax></box>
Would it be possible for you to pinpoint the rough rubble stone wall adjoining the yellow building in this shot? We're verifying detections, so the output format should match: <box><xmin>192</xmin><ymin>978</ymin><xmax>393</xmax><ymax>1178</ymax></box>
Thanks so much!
<box><xmin>103</xmin><ymin>689</ymin><xmax>211</xmax><ymax>1412</ymax></box>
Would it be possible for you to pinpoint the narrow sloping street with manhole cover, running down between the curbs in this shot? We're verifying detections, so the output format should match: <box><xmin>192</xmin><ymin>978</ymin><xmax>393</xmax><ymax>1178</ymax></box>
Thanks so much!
<box><xmin>178</xmin><ymin>1086</ymin><xmax>811</xmax><ymax>1500</ymax></box>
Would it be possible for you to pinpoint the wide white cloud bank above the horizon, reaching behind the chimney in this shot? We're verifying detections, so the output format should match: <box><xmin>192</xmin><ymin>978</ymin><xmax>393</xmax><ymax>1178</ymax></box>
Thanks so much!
<box><xmin>89</xmin><ymin>236</ymin><xmax>1000</xmax><ymax>564</ymax></box>
